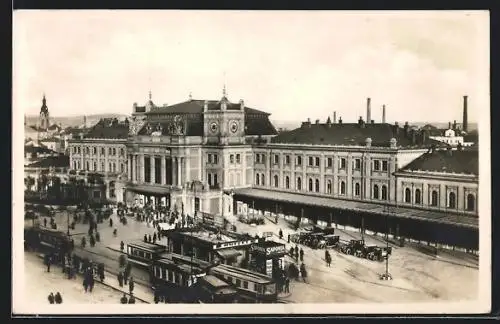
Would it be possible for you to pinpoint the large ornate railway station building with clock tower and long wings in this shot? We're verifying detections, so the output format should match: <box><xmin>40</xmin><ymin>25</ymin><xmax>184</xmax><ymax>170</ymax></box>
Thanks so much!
<box><xmin>69</xmin><ymin>90</ymin><xmax>478</xmax><ymax>249</ymax></box>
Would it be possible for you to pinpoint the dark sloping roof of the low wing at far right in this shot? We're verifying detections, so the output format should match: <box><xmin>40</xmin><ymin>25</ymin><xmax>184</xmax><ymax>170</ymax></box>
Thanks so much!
<box><xmin>401</xmin><ymin>150</ymin><xmax>479</xmax><ymax>175</ymax></box>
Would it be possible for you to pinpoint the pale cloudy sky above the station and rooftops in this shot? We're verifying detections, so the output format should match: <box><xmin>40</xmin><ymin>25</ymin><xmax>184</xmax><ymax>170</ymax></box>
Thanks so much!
<box><xmin>13</xmin><ymin>10</ymin><xmax>489</xmax><ymax>122</ymax></box>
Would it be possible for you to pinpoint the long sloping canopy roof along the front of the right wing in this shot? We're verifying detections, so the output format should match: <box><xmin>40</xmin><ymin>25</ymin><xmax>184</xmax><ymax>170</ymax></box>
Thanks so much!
<box><xmin>234</xmin><ymin>188</ymin><xmax>479</xmax><ymax>228</ymax></box>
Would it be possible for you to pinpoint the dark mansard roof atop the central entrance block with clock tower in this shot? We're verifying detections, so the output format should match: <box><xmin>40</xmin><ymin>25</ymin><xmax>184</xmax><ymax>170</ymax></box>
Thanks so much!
<box><xmin>138</xmin><ymin>100</ymin><xmax>277</xmax><ymax>136</ymax></box>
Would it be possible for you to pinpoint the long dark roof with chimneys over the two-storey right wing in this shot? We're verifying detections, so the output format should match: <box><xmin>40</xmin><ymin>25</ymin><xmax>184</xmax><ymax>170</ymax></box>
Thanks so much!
<box><xmin>272</xmin><ymin>123</ymin><xmax>442</xmax><ymax>147</ymax></box>
